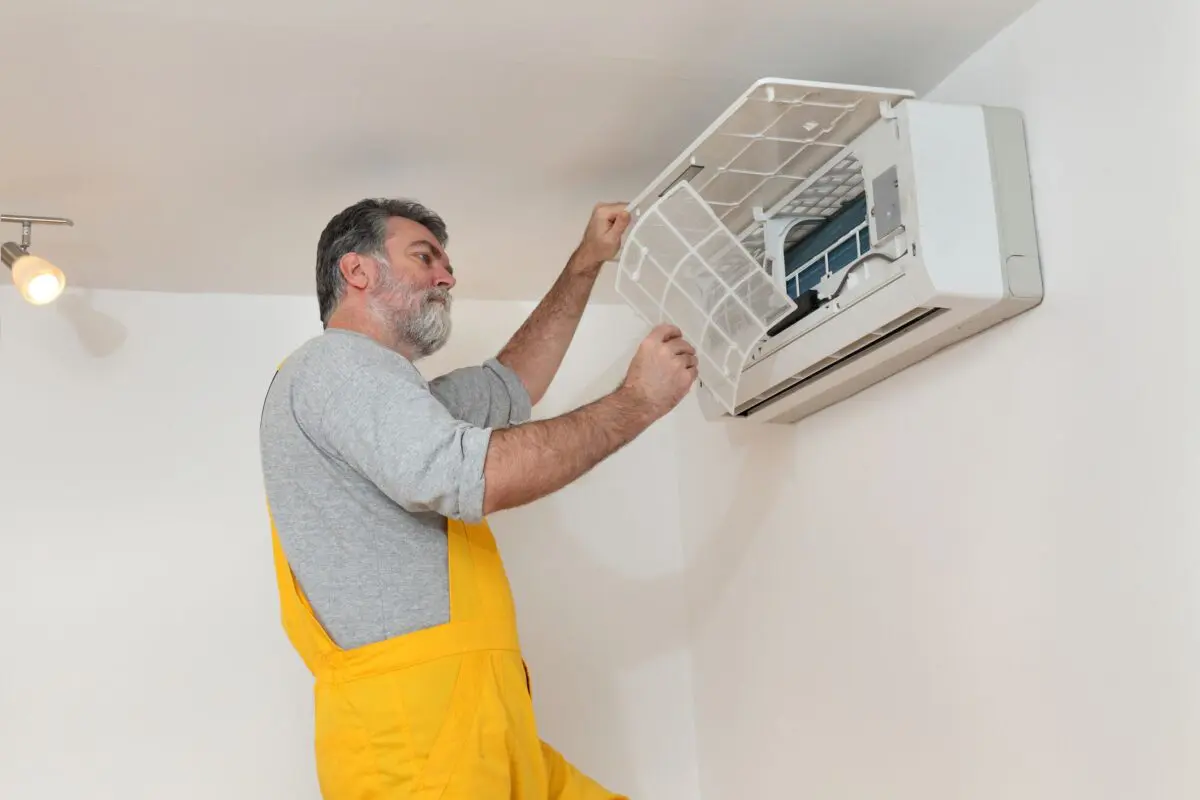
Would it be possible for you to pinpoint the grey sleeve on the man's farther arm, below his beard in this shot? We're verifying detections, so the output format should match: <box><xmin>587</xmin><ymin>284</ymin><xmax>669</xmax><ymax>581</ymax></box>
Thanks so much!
<box><xmin>430</xmin><ymin>359</ymin><xmax>533</xmax><ymax>428</ymax></box>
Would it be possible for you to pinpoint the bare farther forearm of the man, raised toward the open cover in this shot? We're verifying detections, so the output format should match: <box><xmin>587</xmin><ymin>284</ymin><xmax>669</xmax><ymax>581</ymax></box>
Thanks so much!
<box><xmin>497</xmin><ymin>251</ymin><xmax>601</xmax><ymax>404</ymax></box>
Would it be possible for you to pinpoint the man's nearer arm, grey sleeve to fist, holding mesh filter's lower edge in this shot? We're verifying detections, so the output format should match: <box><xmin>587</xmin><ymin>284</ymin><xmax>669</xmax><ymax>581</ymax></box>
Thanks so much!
<box><xmin>293</xmin><ymin>325</ymin><xmax>696</xmax><ymax>522</ymax></box>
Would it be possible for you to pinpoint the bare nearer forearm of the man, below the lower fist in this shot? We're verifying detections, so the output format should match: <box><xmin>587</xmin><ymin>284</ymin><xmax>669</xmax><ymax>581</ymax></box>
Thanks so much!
<box><xmin>484</xmin><ymin>387</ymin><xmax>658</xmax><ymax>513</ymax></box>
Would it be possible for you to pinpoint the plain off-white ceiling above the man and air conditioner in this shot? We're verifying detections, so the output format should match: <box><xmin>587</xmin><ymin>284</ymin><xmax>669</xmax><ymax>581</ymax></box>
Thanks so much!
<box><xmin>0</xmin><ymin>0</ymin><xmax>1032</xmax><ymax>300</ymax></box>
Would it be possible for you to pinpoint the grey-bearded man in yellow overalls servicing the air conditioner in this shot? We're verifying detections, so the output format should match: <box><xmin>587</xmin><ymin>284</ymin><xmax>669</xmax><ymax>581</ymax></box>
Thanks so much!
<box><xmin>260</xmin><ymin>195</ymin><xmax>696</xmax><ymax>800</ymax></box>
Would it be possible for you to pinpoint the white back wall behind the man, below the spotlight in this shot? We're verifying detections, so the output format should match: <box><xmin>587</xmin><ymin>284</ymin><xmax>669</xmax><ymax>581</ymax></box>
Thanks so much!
<box><xmin>0</xmin><ymin>288</ymin><xmax>696</xmax><ymax>800</ymax></box>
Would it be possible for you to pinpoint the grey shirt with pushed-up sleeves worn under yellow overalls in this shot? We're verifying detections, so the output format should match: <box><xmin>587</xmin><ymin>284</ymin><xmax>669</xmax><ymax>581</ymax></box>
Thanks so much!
<box><xmin>259</xmin><ymin>329</ymin><xmax>530</xmax><ymax>649</ymax></box>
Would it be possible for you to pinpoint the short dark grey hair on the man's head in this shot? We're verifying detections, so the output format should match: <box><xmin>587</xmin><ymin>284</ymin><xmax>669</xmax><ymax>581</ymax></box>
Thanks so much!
<box><xmin>317</xmin><ymin>198</ymin><xmax>448</xmax><ymax>326</ymax></box>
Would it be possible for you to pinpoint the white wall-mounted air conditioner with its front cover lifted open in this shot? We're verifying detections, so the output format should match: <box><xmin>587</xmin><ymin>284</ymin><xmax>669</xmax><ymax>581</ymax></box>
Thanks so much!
<box><xmin>617</xmin><ymin>78</ymin><xmax>1043</xmax><ymax>422</ymax></box>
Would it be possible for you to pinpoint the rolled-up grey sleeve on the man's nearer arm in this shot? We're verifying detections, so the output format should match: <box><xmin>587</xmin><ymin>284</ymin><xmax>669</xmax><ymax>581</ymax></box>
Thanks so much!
<box><xmin>312</xmin><ymin>359</ymin><xmax>492</xmax><ymax>522</ymax></box>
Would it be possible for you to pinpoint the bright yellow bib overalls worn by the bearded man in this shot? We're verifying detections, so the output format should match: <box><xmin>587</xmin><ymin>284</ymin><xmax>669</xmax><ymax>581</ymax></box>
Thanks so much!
<box><xmin>271</xmin><ymin>510</ymin><xmax>626</xmax><ymax>800</ymax></box>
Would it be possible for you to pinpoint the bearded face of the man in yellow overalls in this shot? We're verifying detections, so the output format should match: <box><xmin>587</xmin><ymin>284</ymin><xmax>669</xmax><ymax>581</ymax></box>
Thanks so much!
<box><xmin>370</xmin><ymin>217</ymin><xmax>455</xmax><ymax>359</ymax></box>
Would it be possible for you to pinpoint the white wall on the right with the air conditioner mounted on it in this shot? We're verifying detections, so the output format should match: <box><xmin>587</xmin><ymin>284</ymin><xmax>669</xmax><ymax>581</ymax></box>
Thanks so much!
<box><xmin>679</xmin><ymin>0</ymin><xmax>1200</xmax><ymax>800</ymax></box>
